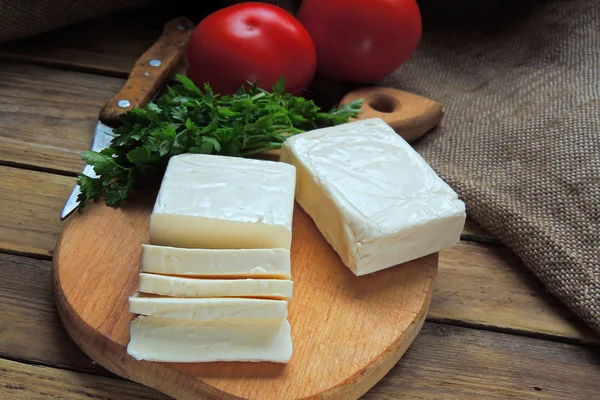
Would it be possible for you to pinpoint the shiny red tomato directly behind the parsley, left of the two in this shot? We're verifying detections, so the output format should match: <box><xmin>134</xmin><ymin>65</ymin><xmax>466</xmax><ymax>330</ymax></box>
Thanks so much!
<box><xmin>186</xmin><ymin>2</ymin><xmax>317</xmax><ymax>94</ymax></box>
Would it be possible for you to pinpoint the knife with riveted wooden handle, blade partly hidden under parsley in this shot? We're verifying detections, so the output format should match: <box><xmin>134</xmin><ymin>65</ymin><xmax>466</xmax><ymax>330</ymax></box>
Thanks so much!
<box><xmin>60</xmin><ymin>17</ymin><xmax>194</xmax><ymax>220</ymax></box>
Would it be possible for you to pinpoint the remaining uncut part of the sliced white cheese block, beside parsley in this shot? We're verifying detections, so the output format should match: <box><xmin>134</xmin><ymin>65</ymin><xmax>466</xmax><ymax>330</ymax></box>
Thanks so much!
<box><xmin>150</xmin><ymin>154</ymin><xmax>296</xmax><ymax>249</ymax></box>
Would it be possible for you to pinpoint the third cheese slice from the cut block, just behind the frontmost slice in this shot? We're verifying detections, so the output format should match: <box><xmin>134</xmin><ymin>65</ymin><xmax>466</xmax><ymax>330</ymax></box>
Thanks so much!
<box><xmin>129</xmin><ymin>293</ymin><xmax>288</xmax><ymax>320</ymax></box>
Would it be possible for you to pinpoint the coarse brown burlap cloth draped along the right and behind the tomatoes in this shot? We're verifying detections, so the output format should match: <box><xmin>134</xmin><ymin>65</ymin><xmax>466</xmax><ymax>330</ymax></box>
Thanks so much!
<box><xmin>0</xmin><ymin>0</ymin><xmax>600</xmax><ymax>333</ymax></box>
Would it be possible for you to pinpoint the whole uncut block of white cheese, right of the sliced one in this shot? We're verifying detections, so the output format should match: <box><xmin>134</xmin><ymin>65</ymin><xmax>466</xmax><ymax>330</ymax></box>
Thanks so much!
<box><xmin>280</xmin><ymin>118</ymin><xmax>466</xmax><ymax>275</ymax></box>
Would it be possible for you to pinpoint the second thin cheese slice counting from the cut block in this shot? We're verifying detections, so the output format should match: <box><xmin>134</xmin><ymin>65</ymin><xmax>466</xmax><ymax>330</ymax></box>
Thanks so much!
<box><xmin>138</xmin><ymin>273</ymin><xmax>293</xmax><ymax>299</ymax></box>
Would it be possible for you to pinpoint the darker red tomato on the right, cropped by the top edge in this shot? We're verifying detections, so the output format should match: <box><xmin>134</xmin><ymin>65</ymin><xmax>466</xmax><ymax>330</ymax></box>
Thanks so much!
<box><xmin>298</xmin><ymin>0</ymin><xmax>421</xmax><ymax>83</ymax></box>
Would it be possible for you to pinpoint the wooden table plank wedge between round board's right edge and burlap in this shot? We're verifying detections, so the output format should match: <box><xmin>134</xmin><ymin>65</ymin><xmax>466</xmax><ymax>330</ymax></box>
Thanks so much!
<box><xmin>428</xmin><ymin>242</ymin><xmax>600</xmax><ymax>344</ymax></box>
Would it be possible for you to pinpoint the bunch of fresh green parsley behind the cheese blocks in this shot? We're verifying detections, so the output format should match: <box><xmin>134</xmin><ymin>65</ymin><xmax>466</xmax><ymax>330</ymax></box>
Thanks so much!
<box><xmin>77</xmin><ymin>75</ymin><xmax>362</xmax><ymax>211</ymax></box>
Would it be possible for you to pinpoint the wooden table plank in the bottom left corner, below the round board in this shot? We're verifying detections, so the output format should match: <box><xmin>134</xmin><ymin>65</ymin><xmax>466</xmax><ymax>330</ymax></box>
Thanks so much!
<box><xmin>0</xmin><ymin>359</ymin><xmax>169</xmax><ymax>400</ymax></box>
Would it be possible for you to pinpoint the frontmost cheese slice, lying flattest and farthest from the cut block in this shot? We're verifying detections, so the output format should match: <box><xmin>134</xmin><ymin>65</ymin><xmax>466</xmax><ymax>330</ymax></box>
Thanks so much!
<box><xmin>127</xmin><ymin>316</ymin><xmax>292</xmax><ymax>363</ymax></box>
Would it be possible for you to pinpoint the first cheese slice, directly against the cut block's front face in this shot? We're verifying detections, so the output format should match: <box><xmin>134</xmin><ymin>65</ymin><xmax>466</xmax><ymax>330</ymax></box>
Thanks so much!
<box><xmin>141</xmin><ymin>244</ymin><xmax>291</xmax><ymax>279</ymax></box>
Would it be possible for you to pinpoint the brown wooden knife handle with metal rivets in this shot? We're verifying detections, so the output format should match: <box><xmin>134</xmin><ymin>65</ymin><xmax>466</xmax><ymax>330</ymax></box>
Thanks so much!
<box><xmin>100</xmin><ymin>17</ymin><xmax>194</xmax><ymax>126</ymax></box>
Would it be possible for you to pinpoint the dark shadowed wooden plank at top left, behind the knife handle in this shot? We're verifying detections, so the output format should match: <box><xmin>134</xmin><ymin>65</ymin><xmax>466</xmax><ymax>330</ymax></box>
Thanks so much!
<box><xmin>0</xmin><ymin>0</ymin><xmax>223</xmax><ymax>78</ymax></box>
